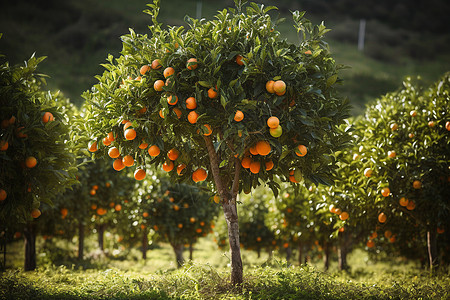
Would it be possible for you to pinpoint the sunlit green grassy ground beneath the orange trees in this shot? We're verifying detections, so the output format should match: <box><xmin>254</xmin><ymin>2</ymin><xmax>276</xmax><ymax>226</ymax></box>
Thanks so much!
<box><xmin>0</xmin><ymin>237</ymin><xmax>450</xmax><ymax>299</ymax></box>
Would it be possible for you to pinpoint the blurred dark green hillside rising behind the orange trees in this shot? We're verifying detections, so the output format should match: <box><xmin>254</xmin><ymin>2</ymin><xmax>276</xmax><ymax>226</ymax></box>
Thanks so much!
<box><xmin>0</xmin><ymin>0</ymin><xmax>450</xmax><ymax>115</ymax></box>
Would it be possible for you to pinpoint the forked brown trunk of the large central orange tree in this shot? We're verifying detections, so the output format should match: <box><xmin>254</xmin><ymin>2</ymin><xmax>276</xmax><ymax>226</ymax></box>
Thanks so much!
<box><xmin>204</xmin><ymin>136</ymin><xmax>243</xmax><ymax>285</ymax></box>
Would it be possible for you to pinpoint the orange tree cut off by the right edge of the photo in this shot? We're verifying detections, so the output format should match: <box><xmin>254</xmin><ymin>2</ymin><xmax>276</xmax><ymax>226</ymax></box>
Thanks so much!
<box><xmin>357</xmin><ymin>74</ymin><xmax>450</xmax><ymax>269</ymax></box>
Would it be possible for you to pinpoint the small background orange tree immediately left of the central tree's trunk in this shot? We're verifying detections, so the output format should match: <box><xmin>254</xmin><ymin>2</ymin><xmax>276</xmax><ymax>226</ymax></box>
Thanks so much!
<box><xmin>134</xmin><ymin>175</ymin><xmax>219</xmax><ymax>266</ymax></box>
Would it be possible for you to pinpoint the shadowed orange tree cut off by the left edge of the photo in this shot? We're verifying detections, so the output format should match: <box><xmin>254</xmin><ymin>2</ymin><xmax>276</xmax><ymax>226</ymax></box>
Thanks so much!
<box><xmin>0</xmin><ymin>48</ymin><xmax>76</xmax><ymax>270</ymax></box>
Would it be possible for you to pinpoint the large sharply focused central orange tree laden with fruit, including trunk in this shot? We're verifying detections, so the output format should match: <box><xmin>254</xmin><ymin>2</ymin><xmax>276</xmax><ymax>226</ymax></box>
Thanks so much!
<box><xmin>84</xmin><ymin>1</ymin><xmax>349</xmax><ymax>284</ymax></box>
